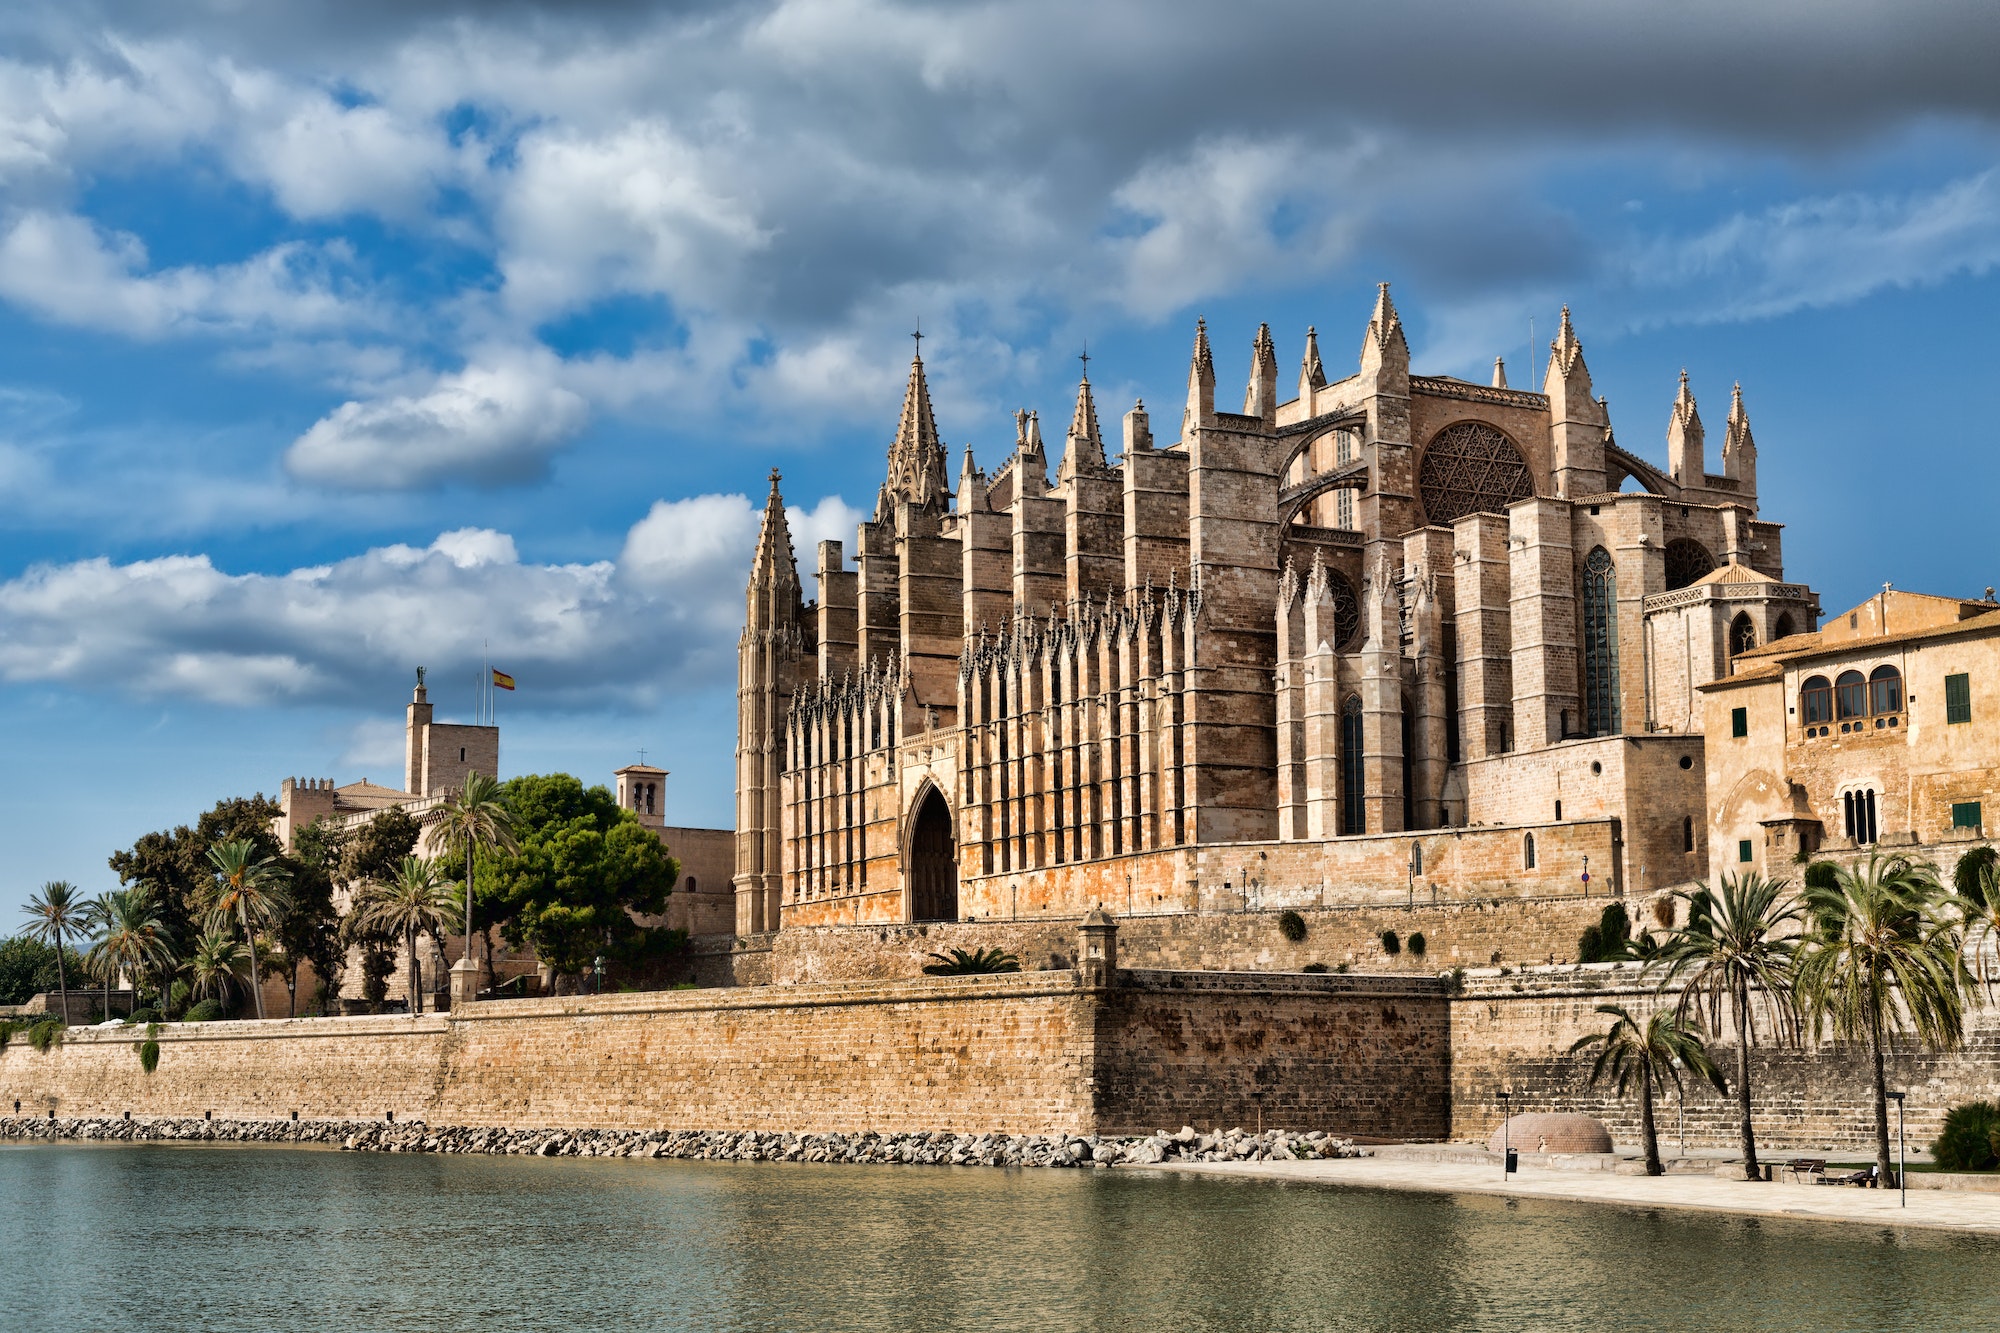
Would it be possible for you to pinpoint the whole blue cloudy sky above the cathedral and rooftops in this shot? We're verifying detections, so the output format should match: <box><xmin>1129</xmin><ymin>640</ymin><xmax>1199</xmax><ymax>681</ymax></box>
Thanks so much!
<box><xmin>0</xmin><ymin>0</ymin><xmax>2000</xmax><ymax>911</ymax></box>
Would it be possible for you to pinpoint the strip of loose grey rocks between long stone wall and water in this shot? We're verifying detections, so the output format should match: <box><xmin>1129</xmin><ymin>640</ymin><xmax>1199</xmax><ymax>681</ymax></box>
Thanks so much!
<box><xmin>0</xmin><ymin>1117</ymin><xmax>1362</xmax><ymax>1167</ymax></box>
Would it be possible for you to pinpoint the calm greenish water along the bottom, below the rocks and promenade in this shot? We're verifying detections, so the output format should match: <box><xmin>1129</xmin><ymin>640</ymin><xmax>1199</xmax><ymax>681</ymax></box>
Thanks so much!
<box><xmin>0</xmin><ymin>1145</ymin><xmax>2000</xmax><ymax>1333</ymax></box>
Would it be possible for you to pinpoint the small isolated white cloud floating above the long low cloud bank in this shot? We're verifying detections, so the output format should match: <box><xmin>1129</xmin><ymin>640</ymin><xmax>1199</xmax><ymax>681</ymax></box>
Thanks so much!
<box><xmin>284</xmin><ymin>352</ymin><xmax>590</xmax><ymax>490</ymax></box>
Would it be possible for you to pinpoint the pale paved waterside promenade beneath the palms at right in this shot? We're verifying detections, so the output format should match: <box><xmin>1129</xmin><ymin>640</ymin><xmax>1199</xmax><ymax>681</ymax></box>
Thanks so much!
<box><xmin>1160</xmin><ymin>1157</ymin><xmax>2000</xmax><ymax>1235</ymax></box>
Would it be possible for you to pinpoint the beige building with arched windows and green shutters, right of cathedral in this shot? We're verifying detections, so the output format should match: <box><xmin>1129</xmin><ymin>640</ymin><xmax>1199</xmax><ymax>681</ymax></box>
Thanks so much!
<box><xmin>1698</xmin><ymin>584</ymin><xmax>2000</xmax><ymax>877</ymax></box>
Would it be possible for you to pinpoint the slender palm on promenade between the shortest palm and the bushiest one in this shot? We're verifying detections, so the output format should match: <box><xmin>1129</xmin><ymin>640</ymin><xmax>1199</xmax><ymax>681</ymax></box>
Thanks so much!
<box><xmin>1660</xmin><ymin>873</ymin><xmax>1802</xmax><ymax>1181</ymax></box>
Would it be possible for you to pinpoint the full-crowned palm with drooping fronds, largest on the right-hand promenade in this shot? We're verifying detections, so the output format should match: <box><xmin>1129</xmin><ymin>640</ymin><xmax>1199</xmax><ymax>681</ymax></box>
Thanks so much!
<box><xmin>1798</xmin><ymin>853</ymin><xmax>1970</xmax><ymax>1181</ymax></box>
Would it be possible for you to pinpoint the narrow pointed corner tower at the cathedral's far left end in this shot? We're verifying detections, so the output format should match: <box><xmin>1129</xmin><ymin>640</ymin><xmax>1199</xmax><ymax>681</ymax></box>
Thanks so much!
<box><xmin>734</xmin><ymin>468</ymin><xmax>812</xmax><ymax>935</ymax></box>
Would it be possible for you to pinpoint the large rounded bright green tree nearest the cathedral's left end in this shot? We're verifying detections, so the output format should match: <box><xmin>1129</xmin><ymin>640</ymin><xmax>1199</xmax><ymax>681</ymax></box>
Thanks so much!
<box><xmin>474</xmin><ymin>773</ymin><xmax>686</xmax><ymax>977</ymax></box>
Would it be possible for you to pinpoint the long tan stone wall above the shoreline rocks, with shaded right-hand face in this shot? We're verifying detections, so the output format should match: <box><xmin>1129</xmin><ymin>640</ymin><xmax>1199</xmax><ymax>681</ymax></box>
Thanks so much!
<box><xmin>0</xmin><ymin>971</ymin><xmax>1446</xmax><ymax>1137</ymax></box>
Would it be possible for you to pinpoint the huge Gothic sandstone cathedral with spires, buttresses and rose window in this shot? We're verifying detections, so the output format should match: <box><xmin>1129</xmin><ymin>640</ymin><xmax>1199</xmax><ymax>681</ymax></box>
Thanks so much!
<box><xmin>736</xmin><ymin>286</ymin><xmax>1818</xmax><ymax>935</ymax></box>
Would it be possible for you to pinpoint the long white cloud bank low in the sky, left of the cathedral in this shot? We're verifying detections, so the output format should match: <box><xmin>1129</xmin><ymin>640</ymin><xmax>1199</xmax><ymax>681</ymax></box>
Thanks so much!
<box><xmin>0</xmin><ymin>494</ymin><xmax>860</xmax><ymax>709</ymax></box>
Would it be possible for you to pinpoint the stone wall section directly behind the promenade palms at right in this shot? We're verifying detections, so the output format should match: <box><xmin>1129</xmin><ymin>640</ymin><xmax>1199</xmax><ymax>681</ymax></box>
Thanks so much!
<box><xmin>1450</xmin><ymin>965</ymin><xmax>2000</xmax><ymax>1151</ymax></box>
